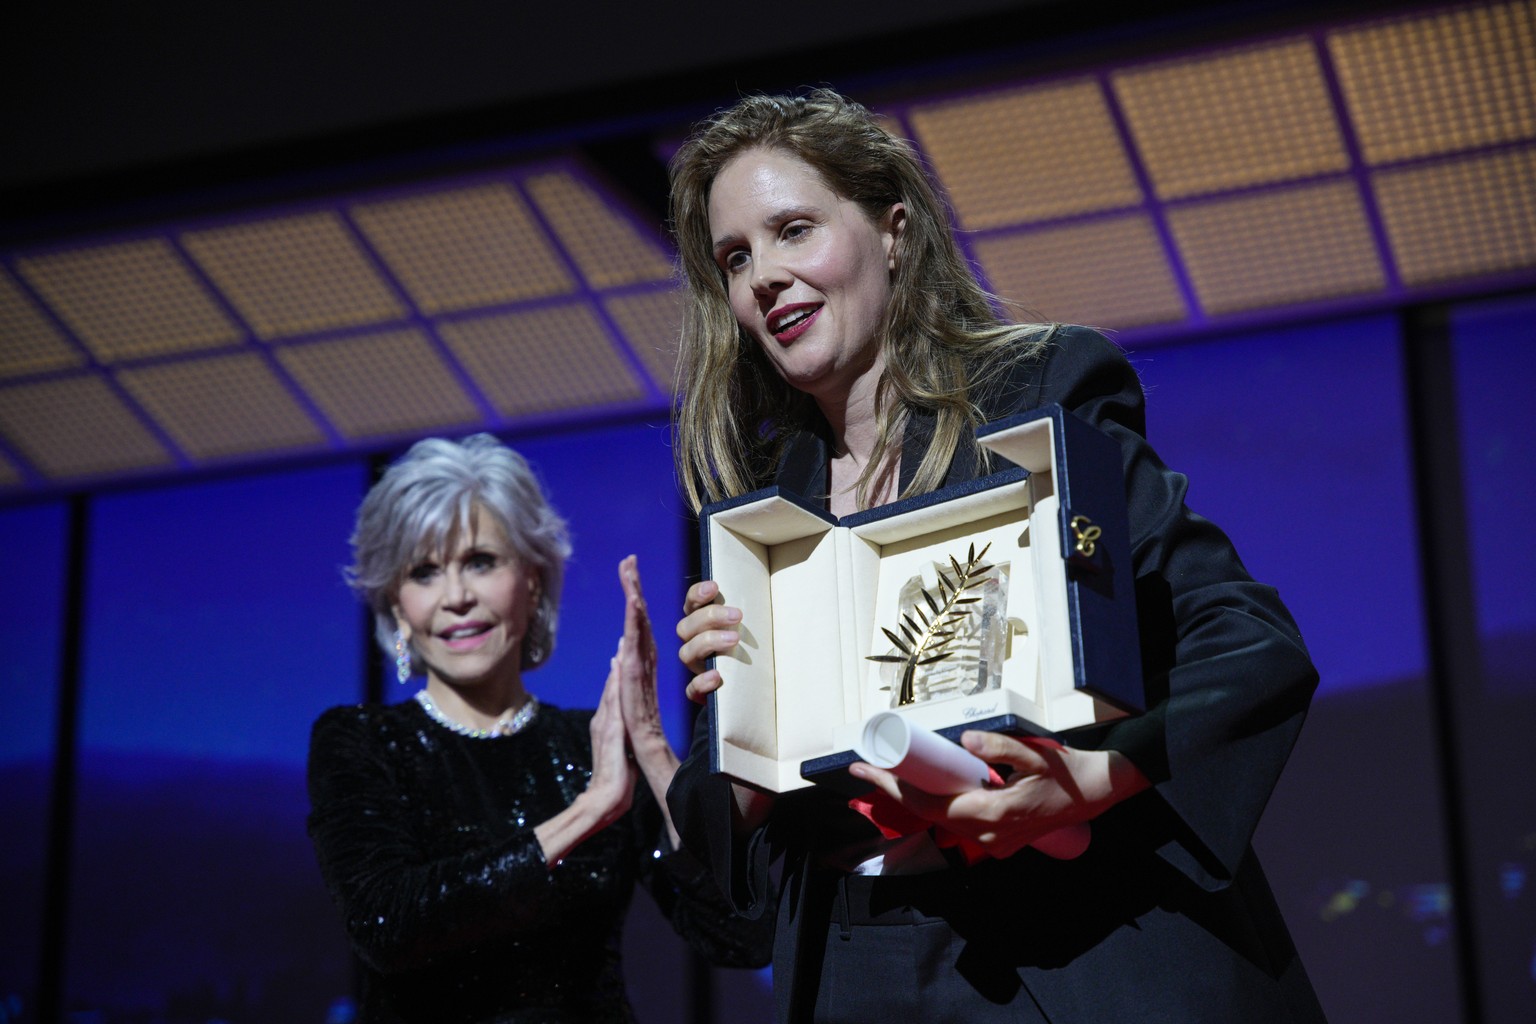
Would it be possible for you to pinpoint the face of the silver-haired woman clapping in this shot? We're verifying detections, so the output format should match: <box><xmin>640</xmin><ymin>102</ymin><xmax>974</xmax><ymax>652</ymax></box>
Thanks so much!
<box><xmin>395</xmin><ymin>507</ymin><xmax>541</xmax><ymax>686</ymax></box>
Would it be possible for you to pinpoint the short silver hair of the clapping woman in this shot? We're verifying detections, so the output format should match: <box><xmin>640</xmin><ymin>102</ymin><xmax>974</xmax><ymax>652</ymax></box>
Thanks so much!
<box><xmin>344</xmin><ymin>434</ymin><xmax>571</xmax><ymax>674</ymax></box>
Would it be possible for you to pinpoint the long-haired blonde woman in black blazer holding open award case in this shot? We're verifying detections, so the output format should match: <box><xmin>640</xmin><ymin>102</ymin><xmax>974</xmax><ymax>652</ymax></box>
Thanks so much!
<box><xmin>668</xmin><ymin>91</ymin><xmax>1322</xmax><ymax>1024</ymax></box>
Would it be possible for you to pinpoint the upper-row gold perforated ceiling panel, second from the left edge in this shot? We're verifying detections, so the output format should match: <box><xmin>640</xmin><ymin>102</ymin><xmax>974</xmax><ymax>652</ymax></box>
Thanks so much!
<box><xmin>15</xmin><ymin>238</ymin><xmax>240</xmax><ymax>362</ymax></box>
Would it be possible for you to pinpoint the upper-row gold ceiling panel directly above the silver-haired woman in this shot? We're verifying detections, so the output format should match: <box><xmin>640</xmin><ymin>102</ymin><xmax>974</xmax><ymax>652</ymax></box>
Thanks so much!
<box><xmin>352</xmin><ymin>184</ymin><xmax>576</xmax><ymax>313</ymax></box>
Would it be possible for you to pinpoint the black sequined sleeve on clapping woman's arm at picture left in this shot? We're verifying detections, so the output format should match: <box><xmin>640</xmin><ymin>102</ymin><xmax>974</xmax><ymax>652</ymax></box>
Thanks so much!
<box><xmin>309</xmin><ymin>706</ymin><xmax>558</xmax><ymax>973</ymax></box>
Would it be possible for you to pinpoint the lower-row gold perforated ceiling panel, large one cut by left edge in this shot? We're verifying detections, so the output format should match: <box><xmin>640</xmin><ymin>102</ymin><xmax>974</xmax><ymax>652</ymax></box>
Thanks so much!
<box><xmin>0</xmin><ymin>376</ymin><xmax>172</xmax><ymax>479</ymax></box>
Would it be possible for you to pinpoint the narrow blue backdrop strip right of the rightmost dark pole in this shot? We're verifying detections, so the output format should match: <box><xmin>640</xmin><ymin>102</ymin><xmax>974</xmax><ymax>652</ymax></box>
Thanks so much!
<box><xmin>1452</xmin><ymin>299</ymin><xmax>1536</xmax><ymax>1021</ymax></box>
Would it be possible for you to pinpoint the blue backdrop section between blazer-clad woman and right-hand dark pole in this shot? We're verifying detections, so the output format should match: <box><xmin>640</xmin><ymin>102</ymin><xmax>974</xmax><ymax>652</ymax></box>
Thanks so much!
<box><xmin>1134</xmin><ymin>316</ymin><xmax>1459</xmax><ymax>1021</ymax></box>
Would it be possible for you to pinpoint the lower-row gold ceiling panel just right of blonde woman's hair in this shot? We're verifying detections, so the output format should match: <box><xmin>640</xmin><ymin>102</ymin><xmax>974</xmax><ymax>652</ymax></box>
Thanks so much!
<box><xmin>975</xmin><ymin>213</ymin><xmax>1186</xmax><ymax>329</ymax></box>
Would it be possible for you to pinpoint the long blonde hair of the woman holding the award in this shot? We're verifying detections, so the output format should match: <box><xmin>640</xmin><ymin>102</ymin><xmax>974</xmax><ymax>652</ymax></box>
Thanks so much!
<box><xmin>670</xmin><ymin>89</ymin><xmax>1051</xmax><ymax>511</ymax></box>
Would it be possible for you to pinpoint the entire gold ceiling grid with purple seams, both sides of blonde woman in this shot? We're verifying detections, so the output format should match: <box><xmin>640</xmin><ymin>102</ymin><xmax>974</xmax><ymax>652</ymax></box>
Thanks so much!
<box><xmin>0</xmin><ymin>0</ymin><xmax>1536</xmax><ymax>496</ymax></box>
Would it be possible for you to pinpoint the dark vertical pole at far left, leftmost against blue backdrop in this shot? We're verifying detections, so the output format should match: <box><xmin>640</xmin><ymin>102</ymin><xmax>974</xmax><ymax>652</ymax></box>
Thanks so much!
<box><xmin>37</xmin><ymin>494</ymin><xmax>91</xmax><ymax>1024</ymax></box>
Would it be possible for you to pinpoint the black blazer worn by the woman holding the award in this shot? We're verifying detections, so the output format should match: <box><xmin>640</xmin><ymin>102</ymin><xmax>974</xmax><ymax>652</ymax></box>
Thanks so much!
<box><xmin>668</xmin><ymin>327</ymin><xmax>1322</xmax><ymax>1022</ymax></box>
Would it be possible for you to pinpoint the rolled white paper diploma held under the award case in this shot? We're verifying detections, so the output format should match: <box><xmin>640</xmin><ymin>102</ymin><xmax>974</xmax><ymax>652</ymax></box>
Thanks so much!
<box><xmin>854</xmin><ymin>711</ymin><xmax>1092</xmax><ymax>860</ymax></box>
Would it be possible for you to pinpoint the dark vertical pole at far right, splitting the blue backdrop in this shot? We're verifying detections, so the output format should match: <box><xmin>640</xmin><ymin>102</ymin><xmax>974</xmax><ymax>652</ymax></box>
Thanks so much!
<box><xmin>1402</xmin><ymin>306</ymin><xmax>1482</xmax><ymax>1024</ymax></box>
